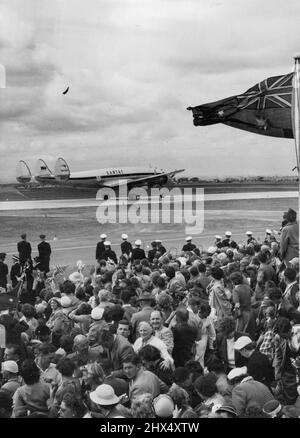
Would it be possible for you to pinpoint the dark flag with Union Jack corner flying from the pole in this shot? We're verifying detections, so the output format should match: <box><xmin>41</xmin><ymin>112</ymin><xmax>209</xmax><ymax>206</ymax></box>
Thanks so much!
<box><xmin>187</xmin><ymin>73</ymin><xmax>294</xmax><ymax>138</ymax></box>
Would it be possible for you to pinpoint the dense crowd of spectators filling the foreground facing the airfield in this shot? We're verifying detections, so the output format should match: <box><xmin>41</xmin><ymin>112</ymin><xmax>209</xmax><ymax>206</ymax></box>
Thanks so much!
<box><xmin>0</xmin><ymin>209</ymin><xmax>300</xmax><ymax>419</ymax></box>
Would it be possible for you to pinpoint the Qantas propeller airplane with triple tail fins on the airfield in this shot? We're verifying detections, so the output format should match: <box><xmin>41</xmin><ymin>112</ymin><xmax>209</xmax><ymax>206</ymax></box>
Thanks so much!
<box><xmin>16</xmin><ymin>157</ymin><xmax>185</xmax><ymax>188</ymax></box>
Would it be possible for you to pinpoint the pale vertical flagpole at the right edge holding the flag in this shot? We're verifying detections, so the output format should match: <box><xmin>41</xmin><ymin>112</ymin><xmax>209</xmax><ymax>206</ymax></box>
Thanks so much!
<box><xmin>292</xmin><ymin>53</ymin><xmax>300</xmax><ymax>288</ymax></box>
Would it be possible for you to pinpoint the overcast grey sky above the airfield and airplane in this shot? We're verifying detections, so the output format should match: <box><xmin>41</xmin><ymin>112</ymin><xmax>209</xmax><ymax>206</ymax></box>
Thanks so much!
<box><xmin>0</xmin><ymin>0</ymin><xmax>300</xmax><ymax>182</ymax></box>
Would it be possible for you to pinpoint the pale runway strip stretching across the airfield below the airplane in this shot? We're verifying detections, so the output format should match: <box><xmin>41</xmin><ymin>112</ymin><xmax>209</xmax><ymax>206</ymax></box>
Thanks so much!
<box><xmin>0</xmin><ymin>191</ymin><xmax>298</xmax><ymax>211</ymax></box>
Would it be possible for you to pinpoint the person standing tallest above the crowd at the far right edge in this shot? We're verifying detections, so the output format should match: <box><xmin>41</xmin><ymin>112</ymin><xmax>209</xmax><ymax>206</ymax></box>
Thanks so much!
<box><xmin>280</xmin><ymin>208</ymin><xmax>299</xmax><ymax>267</ymax></box>
